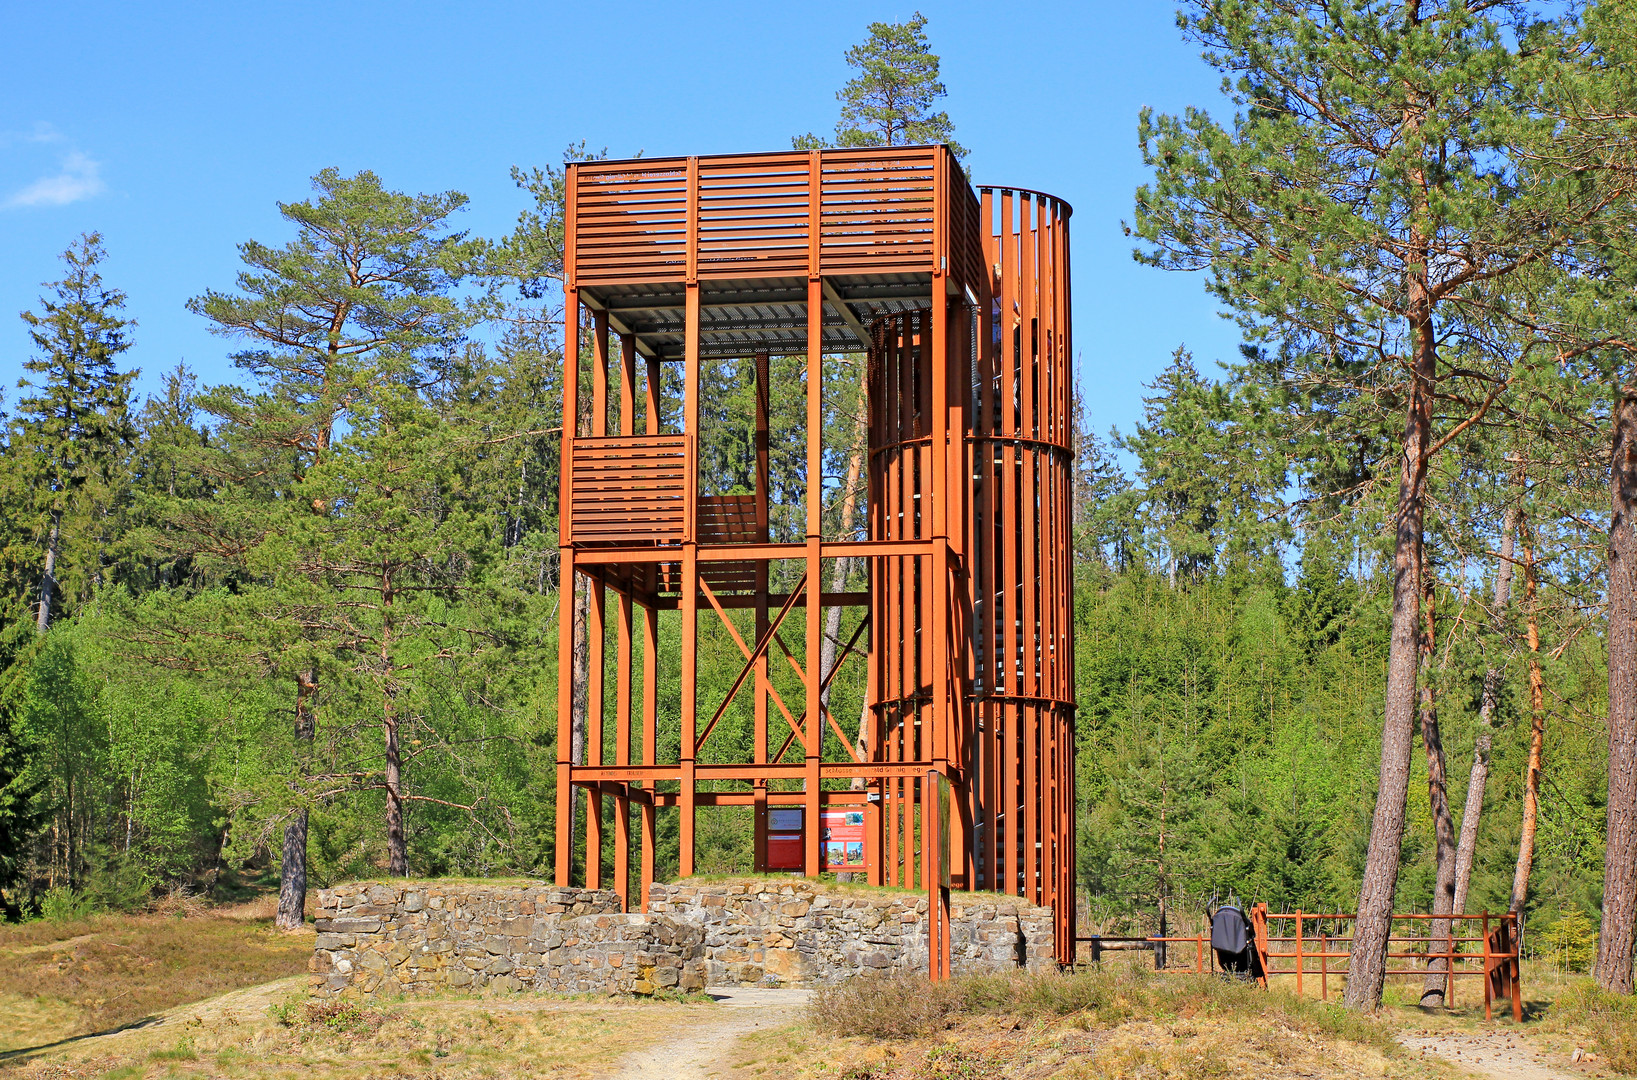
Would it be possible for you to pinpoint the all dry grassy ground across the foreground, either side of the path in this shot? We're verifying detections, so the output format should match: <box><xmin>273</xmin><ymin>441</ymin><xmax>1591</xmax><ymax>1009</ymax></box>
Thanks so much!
<box><xmin>0</xmin><ymin>902</ymin><xmax>1637</xmax><ymax>1080</ymax></box>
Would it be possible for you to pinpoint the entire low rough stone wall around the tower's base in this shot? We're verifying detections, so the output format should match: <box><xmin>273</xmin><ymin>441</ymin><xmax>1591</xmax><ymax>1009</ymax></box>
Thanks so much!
<box><xmin>311</xmin><ymin>879</ymin><xmax>1054</xmax><ymax>997</ymax></box>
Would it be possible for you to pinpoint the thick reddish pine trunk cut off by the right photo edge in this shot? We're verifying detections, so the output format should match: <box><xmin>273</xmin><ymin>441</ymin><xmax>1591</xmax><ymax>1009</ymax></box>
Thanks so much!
<box><xmin>1593</xmin><ymin>386</ymin><xmax>1637</xmax><ymax>993</ymax></box>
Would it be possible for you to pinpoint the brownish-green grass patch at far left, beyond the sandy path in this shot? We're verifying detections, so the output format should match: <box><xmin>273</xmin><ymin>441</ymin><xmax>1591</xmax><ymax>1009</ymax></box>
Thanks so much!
<box><xmin>0</xmin><ymin>900</ymin><xmax>313</xmax><ymax>1052</ymax></box>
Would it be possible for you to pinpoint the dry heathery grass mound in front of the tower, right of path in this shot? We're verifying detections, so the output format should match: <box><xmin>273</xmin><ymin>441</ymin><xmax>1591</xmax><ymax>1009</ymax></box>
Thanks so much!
<box><xmin>785</xmin><ymin>965</ymin><xmax>1441</xmax><ymax>1080</ymax></box>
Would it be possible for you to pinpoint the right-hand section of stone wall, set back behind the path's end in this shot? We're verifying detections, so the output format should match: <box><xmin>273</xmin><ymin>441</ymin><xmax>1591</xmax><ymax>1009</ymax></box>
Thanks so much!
<box><xmin>648</xmin><ymin>877</ymin><xmax>1056</xmax><ymax>987</ymax></box>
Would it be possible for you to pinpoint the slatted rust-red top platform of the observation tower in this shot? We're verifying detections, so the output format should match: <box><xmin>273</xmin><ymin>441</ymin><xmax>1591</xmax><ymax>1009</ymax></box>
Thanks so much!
<box><xmin>565</xmin><ymin>146</ymin><xmax>984</xmax><ymax>360</ymax></box>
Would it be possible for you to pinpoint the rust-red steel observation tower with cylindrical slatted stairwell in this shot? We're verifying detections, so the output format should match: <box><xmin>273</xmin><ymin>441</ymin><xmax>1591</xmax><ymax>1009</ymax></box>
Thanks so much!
<box><xmin>555</xmin><ymin>146</ymin><xmax>1074</xmax><ymax>977</ymax></box>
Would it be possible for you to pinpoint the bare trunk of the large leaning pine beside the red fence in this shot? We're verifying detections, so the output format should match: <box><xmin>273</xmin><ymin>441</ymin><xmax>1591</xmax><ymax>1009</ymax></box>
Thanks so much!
<box><xmin>1344</xmin><ymin>283</ymin><xmax>1437</xmax><ymax>1010</ymax></box>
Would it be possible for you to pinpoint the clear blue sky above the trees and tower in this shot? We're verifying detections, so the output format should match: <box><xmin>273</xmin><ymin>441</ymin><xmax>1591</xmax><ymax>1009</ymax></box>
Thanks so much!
<box><xmin>0</xmin><ymin>0</ymin><xmax>1238</xmax><ymax>432</ymax></box>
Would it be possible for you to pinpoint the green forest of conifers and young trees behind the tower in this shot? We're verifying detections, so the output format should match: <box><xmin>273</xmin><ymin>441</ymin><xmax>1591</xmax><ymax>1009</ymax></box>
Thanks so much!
<box><xmin>0</xmin><ymin>5</ymin><xmax>1629</xmax><ymax>988</ymax></box>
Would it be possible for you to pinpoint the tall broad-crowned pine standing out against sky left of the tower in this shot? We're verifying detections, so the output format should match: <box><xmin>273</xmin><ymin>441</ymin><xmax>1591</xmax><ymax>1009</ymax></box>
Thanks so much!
<box><xmin>172</xmin><ymin>169</ymin><xmax>483</xmax><ymax>909</ymax></box>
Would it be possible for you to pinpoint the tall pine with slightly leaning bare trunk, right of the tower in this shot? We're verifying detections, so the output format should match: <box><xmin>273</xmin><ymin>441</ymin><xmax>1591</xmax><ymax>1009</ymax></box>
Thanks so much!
<box><xmin>1134</xmin><ymin>0</ymin><xmax>1608</xmax><ymax>1008</ymax></box>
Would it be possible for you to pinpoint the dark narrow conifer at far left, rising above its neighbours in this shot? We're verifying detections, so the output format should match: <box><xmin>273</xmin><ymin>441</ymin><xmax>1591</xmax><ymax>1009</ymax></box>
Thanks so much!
<box><xmin>10</xmin><ymin>232</ymin><xmax>138</xmax><ymax>633</ymax></box>
